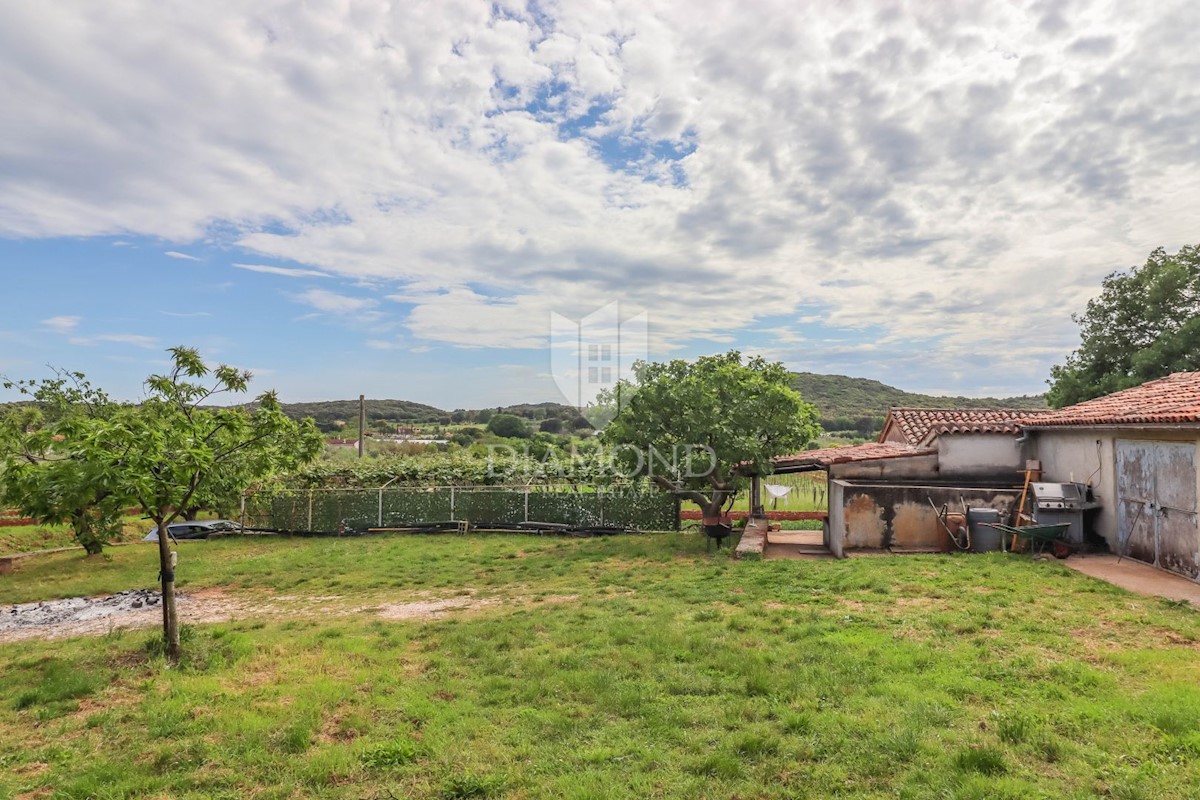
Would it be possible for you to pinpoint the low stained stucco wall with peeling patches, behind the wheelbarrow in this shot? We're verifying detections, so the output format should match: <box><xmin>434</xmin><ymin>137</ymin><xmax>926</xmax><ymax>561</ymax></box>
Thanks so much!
<box><xmin>829</xmin><ymin>480</ymin><xmax>1021</xmax><ymax>558</ymax></box>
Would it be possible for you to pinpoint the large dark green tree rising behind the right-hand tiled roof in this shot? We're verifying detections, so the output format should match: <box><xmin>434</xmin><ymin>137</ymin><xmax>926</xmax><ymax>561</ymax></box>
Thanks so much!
<box><xmin>1046</xmin><ymin>245</ymin><xmax>1200</xmax><ymax>408</ymax></box>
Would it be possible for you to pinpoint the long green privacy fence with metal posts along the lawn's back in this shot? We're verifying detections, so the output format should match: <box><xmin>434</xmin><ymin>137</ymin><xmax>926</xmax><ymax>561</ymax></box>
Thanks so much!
<box><xmin>242</xmin><ymin>486</ymin><xmax>679</xmax><ymax>531</ymax></box>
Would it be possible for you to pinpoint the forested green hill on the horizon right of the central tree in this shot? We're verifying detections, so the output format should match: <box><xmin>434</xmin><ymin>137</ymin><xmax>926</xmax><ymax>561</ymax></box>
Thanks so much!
<box><xmin>792</xmin><ymin>372</ymin><xmax>1046</xmax><ymax>419</ymax></box>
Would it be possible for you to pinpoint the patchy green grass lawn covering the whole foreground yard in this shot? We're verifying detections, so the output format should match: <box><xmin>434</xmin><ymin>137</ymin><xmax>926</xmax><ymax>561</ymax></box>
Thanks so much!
<box><xmin>0</xmin><ymin>534</ymin><xmax>1200</xmax><ymax>800</ymax></box>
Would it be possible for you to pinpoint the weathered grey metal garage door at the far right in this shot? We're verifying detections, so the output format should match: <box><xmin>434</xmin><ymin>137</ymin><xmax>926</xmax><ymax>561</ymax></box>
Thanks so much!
<box><xmin>1117</xmin><ymin>440</ymin><xmax>1200</xmax><ymax>579</ymax></box>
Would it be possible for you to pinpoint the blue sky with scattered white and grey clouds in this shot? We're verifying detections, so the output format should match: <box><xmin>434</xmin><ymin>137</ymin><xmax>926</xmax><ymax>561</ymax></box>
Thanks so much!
<box><xmin>0</xmin><ymin>0</ymin><xmax>1200</xmax><ymax>408</ymax></box>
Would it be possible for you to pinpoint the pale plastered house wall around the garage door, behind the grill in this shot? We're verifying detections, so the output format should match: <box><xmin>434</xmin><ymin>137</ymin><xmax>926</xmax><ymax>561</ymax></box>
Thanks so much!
<box><xmin>1030</xmin><ymin>428</ymin><xmax>1200</xmax><ymax>553</ymax></box>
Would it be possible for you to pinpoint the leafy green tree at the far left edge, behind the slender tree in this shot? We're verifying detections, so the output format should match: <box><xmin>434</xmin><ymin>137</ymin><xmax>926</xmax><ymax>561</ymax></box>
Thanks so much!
<box><xmin>0</xmin><ymin>372</ymin><xmax>127</xmax><ymax>555</ymax></box>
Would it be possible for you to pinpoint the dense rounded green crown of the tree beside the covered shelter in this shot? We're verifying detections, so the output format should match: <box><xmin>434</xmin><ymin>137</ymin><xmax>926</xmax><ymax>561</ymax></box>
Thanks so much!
<box><xmin>601</xmin><ymin>350</ymin><xmax>820</xmax><ymax>517</ymax></box>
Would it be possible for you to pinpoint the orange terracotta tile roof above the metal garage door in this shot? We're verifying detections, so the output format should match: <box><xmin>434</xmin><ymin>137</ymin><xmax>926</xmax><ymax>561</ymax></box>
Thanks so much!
<box><xmin>1021</xmin><ymin>372</ymin><xmax>1200</xmax><ymax>428</ymax></box>
